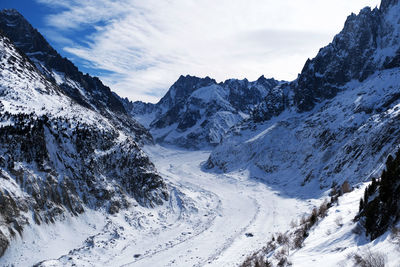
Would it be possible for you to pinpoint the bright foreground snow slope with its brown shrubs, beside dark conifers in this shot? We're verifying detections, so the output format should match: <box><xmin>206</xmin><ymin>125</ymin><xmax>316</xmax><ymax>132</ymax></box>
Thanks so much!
<box><xmin>242</xmin><ymin>183</ymin><xmax>400</xmax><ymax>267</ymax></box>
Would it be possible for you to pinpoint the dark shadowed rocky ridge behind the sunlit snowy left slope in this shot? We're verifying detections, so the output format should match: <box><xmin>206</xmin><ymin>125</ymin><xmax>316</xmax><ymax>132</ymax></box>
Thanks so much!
<box><xmin>0</xmin><ymin>9</ymin><xmax>152</xmax><ymax>146</ymax></box>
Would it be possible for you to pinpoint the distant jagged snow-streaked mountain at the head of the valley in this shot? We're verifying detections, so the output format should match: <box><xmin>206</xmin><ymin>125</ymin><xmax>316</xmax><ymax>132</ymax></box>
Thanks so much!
<box><xmin>125</xmin><ymin>75</ymin><xmax>281</xmax><ymax>148</ymax></box>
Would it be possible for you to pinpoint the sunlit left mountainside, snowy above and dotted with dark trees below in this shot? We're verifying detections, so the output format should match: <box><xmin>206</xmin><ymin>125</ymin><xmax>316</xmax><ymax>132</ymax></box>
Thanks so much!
<box><xmin>0</xmin><ymin>15</ymin><xmax>168</xmax><ymax>256</ymax></box>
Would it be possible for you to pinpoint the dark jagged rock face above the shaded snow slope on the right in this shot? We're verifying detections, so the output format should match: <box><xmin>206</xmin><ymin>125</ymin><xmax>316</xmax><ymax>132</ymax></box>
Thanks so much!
<box><xmin>254</xmin><ymin>1</ymin><xmax>400</xmax><ymax>121</ymax></box>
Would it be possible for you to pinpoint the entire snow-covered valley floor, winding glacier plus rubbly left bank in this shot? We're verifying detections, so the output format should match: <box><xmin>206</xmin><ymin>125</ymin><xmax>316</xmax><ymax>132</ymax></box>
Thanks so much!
<box><xmin>2</xmin><ymin>145</ymin><xmax>320</xmax><ymax>266</ymax></box>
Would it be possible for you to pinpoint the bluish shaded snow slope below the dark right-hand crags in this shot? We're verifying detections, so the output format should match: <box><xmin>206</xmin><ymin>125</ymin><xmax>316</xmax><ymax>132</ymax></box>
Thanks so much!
<box><xmin>209</xmin><ymin>68</ymin><xmax>400</xmax><ymax>192</ymax></box>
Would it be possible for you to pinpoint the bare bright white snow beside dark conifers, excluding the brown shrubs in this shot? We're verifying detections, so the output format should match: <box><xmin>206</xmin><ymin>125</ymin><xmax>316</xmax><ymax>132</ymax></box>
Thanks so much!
<box><xmin>290</xmin><ymin>183</ymin><xmax>400</xmax><ymax>267</ymax></box>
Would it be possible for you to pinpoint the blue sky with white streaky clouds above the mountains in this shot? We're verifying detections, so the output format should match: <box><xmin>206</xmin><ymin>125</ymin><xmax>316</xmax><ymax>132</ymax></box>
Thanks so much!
<box><xmin>0</xmin><ymin>0</ymin><xmax>380</xmax><ymax>103</ymax></box>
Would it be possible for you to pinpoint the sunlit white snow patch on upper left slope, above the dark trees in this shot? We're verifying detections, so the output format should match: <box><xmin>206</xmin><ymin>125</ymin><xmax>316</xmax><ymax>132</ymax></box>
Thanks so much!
<box><xmin>0</xmin><ymin>34</ymin><xmax>114</xmax><ymax>128</ymax></box>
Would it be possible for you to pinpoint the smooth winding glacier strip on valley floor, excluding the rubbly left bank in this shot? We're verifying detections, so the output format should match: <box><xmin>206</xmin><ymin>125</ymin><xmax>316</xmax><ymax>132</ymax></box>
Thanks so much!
<box><xmin>140</xmin><ymin>146</ymin><xmax>314</xmax><ymax>266</ymax></box>
